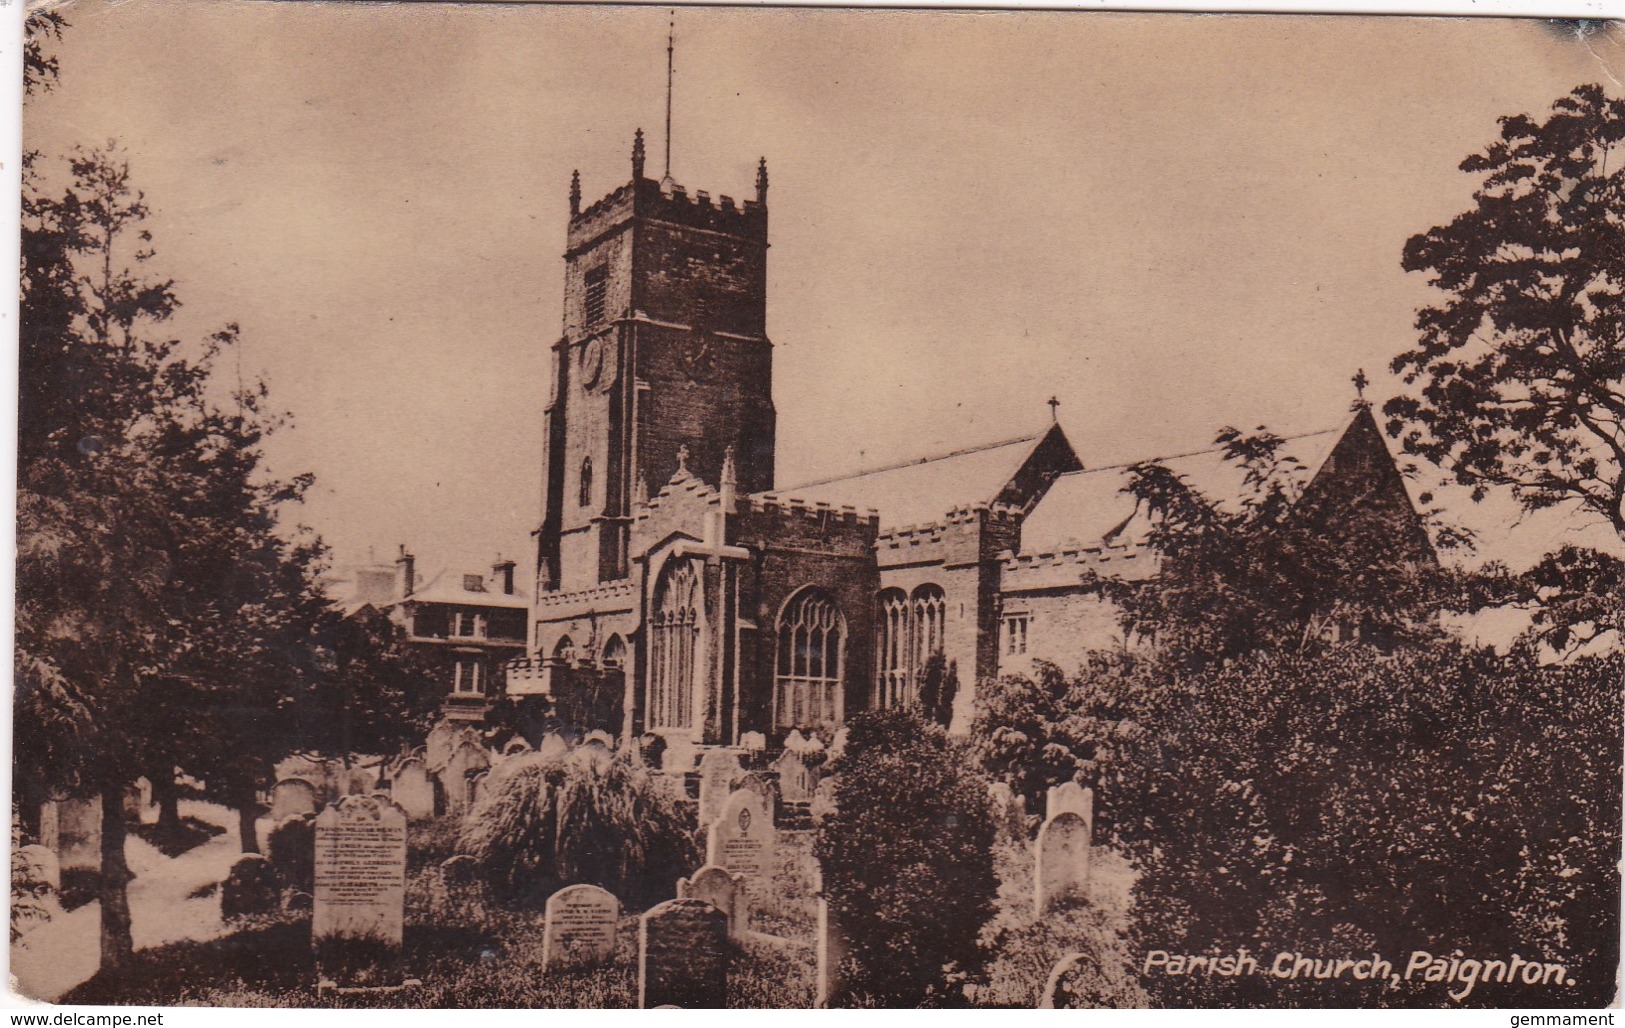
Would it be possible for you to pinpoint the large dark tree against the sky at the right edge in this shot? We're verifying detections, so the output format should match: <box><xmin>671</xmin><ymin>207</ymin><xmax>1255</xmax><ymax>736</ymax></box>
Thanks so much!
<box><xmin>1383</xmin><ymin>84</ymin><xmax>1625</xmax><ymax>538</ymax></box>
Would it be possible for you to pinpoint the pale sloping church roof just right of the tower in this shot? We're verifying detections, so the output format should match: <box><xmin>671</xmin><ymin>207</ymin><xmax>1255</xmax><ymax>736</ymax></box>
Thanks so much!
<box><xmin>774</xmin><ymin>432</ymin><xmax>1045</xmax><ymax>529</ymax></box>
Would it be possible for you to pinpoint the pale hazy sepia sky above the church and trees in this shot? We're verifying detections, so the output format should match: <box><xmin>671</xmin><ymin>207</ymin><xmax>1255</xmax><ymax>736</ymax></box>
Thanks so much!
<box><xmin>24</xmin><ymin>0</ymin><xmax>1625</xmax><ymax>587</ymax></box>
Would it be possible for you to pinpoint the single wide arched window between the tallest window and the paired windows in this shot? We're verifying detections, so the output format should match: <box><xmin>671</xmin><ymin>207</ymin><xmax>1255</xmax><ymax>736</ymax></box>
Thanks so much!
<box><xmin>774</xmin><ymin>588</ymin><xmax>847</xmax><ymax>728</ymax></box>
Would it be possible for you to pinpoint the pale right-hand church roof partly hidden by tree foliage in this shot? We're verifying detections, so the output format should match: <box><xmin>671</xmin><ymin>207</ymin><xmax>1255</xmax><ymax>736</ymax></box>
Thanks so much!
<box><xmin>1021</xmin><ymin>427</ymin><xmax>1347</xmax><ymax>554</ymax></box>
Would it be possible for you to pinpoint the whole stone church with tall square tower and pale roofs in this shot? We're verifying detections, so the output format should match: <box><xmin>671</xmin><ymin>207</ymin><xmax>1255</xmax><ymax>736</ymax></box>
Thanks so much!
<box><xmin>505</xmin><ymin>132</ymin><xmax>1432</xmax><ymax>750</ymax></box>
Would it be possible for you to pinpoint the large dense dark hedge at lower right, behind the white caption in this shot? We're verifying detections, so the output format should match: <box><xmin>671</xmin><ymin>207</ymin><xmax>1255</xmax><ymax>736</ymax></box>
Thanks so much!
<box><xmin>968</xmin><ymin>646</ymin><xmax>1625</xmax><ymax>1007</ymax></box>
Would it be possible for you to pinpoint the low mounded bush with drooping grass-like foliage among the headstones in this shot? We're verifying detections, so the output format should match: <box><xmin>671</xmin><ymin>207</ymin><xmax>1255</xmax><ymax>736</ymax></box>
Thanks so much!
<box><xmin>460</xmin><ymin>750</ymin><xmax>700</xmax><ymax>909</ymax></box>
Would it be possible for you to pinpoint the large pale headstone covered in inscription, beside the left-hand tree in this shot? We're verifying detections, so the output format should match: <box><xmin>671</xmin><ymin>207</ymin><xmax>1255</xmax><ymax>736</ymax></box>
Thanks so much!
<box><xmin>310</xmin><ymin>796</ymin><xmax>406</xmax><ymax>965</ymax></box>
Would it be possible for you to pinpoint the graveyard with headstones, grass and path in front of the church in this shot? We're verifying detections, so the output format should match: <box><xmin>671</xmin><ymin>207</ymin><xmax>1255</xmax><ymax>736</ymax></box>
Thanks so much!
<box><xmin>15</xmin><ymin>708</ymin><xmax>1133</xmax><ymax>1009</ymax></box>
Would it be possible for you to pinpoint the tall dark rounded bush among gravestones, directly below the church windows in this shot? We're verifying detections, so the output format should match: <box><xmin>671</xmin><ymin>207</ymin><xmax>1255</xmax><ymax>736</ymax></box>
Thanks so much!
<box><xmin>814</xmin><ymin>710</ymin><xmax>998</xmax><ymax>1007</ymax></box>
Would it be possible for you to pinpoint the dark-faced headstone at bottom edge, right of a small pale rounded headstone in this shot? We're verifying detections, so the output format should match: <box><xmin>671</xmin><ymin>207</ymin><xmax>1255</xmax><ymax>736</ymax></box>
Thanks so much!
<box><xmin>637</xmin><ymin>900</ymin><xmax>728</xmax><ymax>1010</ymax></box>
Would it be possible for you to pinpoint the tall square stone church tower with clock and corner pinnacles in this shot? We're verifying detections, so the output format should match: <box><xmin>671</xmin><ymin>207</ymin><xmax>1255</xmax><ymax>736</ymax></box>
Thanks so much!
<box><xmin>538</xmin><ymin>130</ymin><xmax>775</xmax><ymax>591</ymax></box>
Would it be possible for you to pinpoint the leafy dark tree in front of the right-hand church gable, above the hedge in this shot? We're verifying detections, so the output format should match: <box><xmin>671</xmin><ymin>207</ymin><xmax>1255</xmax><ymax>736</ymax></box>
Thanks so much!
<box><xmin>1084</xmin><ymin>409</ymin><xmax>1463</xmax><ymax>666</ymax></box>
